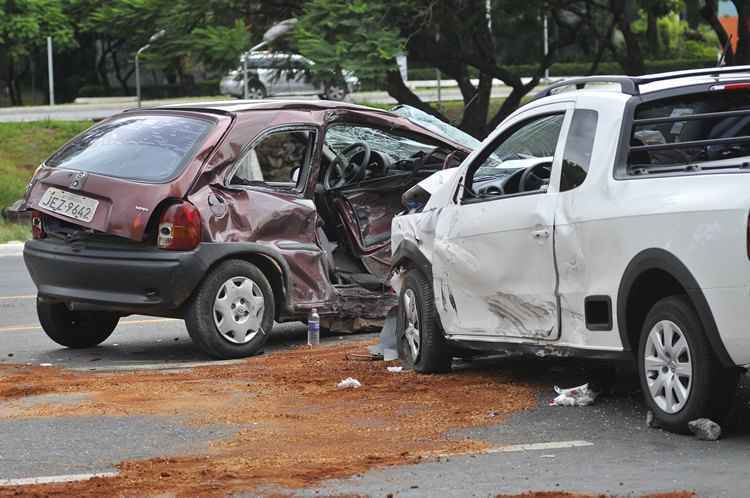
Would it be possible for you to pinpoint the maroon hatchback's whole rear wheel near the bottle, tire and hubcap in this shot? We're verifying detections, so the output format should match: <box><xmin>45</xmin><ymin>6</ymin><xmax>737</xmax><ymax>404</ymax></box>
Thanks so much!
<box><xmin>185</xmin><ymin>260</ymin><xmax>276</xmax><ymax>360</ymax></box>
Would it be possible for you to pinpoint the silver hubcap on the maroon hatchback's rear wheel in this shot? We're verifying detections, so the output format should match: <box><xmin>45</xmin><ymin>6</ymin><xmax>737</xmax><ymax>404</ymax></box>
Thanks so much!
<box><xmin>213</xmin><ymin>277</ymin><xmax>265</xmax><ymax>344</ymax></box>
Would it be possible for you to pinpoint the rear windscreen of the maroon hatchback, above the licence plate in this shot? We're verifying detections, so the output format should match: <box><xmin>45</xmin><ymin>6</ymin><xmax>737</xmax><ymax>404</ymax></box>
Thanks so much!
<box><xmin>45</xmin><ymin>115</ymin><xmax>213</xmax><ymax>182</ymax></box>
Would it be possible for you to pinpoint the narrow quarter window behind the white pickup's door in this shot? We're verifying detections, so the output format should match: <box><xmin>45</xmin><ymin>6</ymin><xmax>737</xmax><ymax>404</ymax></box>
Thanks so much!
<box><xmin>560</xmin><ymin>109</ymin><xmax>599</xmax><ymax>192</ymax></box>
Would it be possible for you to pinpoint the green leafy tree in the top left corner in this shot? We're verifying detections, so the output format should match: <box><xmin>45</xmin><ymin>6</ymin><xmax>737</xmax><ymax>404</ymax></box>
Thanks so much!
<box><xmin>0</xmin><ymin>0</ymin><xmax>76</xmax><ymax>105</ymax></box>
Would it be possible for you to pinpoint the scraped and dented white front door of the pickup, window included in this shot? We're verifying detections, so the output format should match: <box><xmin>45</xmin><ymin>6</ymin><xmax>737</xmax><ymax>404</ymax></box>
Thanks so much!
<box><xmin>433</xmin><ymin>103</ymin><xmax>570</xmax><ymax>340</ymax></box>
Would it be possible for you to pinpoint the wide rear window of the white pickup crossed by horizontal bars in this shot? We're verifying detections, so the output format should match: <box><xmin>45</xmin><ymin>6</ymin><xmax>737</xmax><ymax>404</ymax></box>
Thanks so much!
<box><xmin>628</xmin><ymin>89</ymin><xmax>750</xmax><ymax>174</ymax></box>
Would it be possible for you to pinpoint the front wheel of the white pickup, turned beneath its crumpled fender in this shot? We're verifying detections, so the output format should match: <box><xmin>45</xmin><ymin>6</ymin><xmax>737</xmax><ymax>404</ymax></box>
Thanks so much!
<box><xmin>397</xmin><ymin>270</ymin><xmax>453</xmax><ymax>373</ymax></box>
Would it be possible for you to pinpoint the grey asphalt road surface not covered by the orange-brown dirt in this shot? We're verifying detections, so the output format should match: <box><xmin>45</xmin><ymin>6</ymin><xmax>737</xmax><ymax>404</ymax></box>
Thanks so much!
<box><xmin>0</xmin><ymin>247</ymin><xmax>750</xmax><ymax>497</ymax></box>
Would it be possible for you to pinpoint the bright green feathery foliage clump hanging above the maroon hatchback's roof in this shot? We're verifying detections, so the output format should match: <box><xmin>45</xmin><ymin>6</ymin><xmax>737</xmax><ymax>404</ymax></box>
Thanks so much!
<box><xmin>296</xmin><ymin>0</ymin><xmax>408</xmax><ymax>82</ymax></box>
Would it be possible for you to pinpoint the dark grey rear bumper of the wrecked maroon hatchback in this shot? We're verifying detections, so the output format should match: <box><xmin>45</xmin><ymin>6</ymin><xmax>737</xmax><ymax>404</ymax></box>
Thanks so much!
<box><xmin>23</xmin><ymin>239</ymin><xmax>210</xmax><ymax>315</ymax></box>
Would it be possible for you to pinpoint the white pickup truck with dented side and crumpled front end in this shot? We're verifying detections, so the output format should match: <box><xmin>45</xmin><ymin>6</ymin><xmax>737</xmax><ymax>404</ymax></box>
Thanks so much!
<box><xmin>391</xmin><ymin>67</ymin><xmax>750</xmax><ymax>432</ymax></box>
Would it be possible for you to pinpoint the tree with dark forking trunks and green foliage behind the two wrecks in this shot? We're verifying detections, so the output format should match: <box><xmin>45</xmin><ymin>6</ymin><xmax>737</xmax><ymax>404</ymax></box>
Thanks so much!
<box><xmin>297</xmin><ymin>0</ymin><xmax>580</xmax><ymax>137</ymax></box>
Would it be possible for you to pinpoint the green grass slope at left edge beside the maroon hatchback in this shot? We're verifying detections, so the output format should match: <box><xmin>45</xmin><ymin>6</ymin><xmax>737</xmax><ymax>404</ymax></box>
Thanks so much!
<box><xmin>0</xmin><ymin>121</ymin><xmax>91</xmax><ymax>209</ymax></box>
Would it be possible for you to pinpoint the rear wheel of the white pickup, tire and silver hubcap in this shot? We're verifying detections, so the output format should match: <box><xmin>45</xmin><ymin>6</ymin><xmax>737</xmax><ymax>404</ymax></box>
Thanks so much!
<box><xmin>637</xmin><ymin>296</ymin><xmax>739</xmax><ymax>434</ymax></box>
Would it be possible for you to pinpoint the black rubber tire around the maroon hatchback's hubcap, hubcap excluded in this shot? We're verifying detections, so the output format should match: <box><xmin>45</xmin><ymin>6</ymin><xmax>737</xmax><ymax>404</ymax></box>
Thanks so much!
<box><xmin>185</xmin><ymin>259</ymin><xmax>276</xmax><ymax>360</ymax></box>
